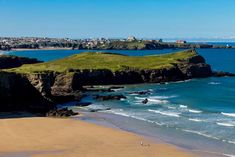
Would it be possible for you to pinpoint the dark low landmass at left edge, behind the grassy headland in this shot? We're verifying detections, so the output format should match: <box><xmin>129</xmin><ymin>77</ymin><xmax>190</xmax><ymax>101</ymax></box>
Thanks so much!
<box><xmin>0</xmin><ymin>55</ymin><xmax>42</xmax><ymax>69</ymax></box>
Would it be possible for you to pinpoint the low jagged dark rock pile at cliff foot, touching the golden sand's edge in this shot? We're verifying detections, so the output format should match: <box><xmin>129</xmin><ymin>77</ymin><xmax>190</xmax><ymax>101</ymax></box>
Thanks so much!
<box><xmin>46</xmin><ymin>108</ymin><xmax>78</xmax><ymax>117</ymax></box>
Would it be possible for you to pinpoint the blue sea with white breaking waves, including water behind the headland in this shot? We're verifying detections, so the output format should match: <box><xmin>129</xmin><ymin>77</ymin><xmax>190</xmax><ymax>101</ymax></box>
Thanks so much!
<box><xmin>9</xmin><ymin>49</ymin><xmax>235</xmax><ymax>156</ymax></box>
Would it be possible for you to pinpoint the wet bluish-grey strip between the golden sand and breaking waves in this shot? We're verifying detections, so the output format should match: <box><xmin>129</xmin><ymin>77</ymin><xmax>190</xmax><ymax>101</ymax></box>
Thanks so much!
<box><xmin>74</xmin><ymin>110</ymin><xmax>226</xmax><ymax>157</ymax></box>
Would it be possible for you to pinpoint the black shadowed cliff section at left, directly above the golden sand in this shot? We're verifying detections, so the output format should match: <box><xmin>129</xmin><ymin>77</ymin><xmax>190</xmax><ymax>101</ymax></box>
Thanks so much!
<box><xmin>0</xmin><ymin>72</ymin><xmax>54</xmax><ymax>112</ymax></box>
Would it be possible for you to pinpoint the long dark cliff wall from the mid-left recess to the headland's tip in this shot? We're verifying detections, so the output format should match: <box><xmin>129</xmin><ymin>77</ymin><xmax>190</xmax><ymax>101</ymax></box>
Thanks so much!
<box><xmin>67</xmin><ymin>55</ymin><xmax>212</xmax><ymax>86</ymax></box>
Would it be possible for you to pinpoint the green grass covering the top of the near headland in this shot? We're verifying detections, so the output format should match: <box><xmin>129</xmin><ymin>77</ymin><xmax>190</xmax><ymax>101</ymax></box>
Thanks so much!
<box><xmin>7</xmin><ymin>50</ymin><xmax>197</xmax><ymax>73</ymax></box>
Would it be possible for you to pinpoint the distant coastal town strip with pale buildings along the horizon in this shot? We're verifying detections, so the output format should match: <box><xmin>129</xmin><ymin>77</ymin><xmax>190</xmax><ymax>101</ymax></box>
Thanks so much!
<box><xmin>0</xmin><ymin>36</ymin><xmax>232</xmax><ymax>51</ymax></box>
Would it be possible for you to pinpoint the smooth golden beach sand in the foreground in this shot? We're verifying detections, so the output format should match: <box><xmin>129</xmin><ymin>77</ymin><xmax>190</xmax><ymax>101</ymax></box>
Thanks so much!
<box><xmin>0</xmin><ymin>117</ymin><xmax>194</xmax><ymax>157</ymax></box>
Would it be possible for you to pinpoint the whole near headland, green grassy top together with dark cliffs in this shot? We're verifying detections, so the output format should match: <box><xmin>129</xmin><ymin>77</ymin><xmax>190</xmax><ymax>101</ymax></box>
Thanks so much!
<box><xmin>0</xmin><ymin>50</ymin><xmax>212</xmax><ymax>110</ymax></box>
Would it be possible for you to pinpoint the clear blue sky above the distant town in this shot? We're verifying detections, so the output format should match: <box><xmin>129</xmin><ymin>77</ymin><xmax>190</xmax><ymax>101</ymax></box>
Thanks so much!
<box><xmin>0</xmin><ymin>0</ymin><xmax>235</xmax><ymax>38</ymax></box>
